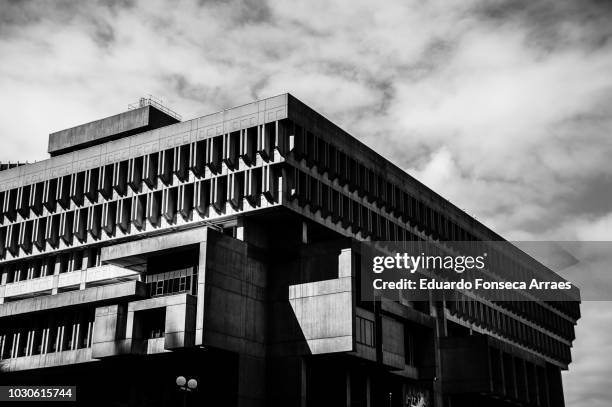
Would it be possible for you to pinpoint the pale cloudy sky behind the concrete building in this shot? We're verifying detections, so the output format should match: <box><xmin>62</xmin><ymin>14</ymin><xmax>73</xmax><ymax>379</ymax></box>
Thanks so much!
<box><xmin>0</xmin><ymin>0</ymin><xmax>612</xmax><ymax>407</ymax></box>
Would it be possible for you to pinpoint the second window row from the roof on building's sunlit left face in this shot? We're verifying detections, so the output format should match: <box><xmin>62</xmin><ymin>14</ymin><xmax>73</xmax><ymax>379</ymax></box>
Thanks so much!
<box><xmin>0</xmin><ymin>166</ymin><xmax>278</xmax><ymax>257</ymax></box>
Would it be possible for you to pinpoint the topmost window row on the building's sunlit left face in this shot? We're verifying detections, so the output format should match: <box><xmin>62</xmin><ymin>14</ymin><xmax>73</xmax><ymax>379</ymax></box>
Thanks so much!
<box><xmin>0</xmin><ymin>122</ymin><xmax>288</xmax><ymax>223</ymax></box>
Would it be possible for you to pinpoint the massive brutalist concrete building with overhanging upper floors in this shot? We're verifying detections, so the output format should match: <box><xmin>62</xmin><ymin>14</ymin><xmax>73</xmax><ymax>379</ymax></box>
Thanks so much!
<box><xmin>0</xmin><ymin>94</ymin><xmax>580</xmax><ymax>407</ymax></box>
